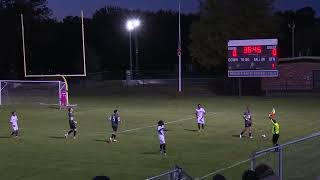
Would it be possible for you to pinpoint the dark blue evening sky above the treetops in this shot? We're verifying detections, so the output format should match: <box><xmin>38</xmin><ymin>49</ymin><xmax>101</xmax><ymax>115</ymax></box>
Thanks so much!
<box><xmin>48</xmin><ymin>0</ymin><xmax>320</xmax><ymax>19</ymax></box>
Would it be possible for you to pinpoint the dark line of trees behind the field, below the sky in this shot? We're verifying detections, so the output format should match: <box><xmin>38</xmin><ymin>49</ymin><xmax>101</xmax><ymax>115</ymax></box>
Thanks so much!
<box><xmin>0</xmin><ymin>0</ymin><xmax>320</xmax><ymax>78</ymax></box>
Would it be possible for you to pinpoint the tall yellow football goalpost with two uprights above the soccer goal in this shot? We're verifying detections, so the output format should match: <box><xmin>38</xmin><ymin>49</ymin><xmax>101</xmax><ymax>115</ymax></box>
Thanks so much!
<box><xmin>20</xmin><ymin>10</ymin><xmax>87</xmax><ymax>105</ymax></box>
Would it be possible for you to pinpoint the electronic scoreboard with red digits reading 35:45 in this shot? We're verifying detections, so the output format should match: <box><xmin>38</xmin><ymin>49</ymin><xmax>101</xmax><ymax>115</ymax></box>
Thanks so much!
<box><xmin>228</xmin><ymin>39</ymin><xmax>278</xmax><ymax>77</ymax></box>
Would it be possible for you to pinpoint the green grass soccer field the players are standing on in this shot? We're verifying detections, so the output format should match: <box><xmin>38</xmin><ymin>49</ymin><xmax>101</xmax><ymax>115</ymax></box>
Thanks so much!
<box><xmin>0</xmin><ymin>89</ymin><xmax>320</xmax><ymax>180</ymax></box>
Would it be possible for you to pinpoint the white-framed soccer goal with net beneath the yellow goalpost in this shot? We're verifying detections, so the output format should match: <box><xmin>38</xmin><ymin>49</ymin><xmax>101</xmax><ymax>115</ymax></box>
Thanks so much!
<box><xmin>0</xmin><ymin>80</ymin><xmax>66</xmax><ymax>106</ymax></box>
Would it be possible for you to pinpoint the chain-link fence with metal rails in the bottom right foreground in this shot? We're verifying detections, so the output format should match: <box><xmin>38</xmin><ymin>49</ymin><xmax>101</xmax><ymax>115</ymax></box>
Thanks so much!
<box><xmin>197</xmin><ymin>132</ymin><xmax>320</xmax><ymax>180</ymax></box>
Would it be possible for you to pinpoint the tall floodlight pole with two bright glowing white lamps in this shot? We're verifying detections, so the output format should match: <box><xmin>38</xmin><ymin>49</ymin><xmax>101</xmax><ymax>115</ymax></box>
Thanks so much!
<box><xmin>126</xmin><ymin>19</ymin><xmax>141</xmax><ymax>74</ymax></box>
